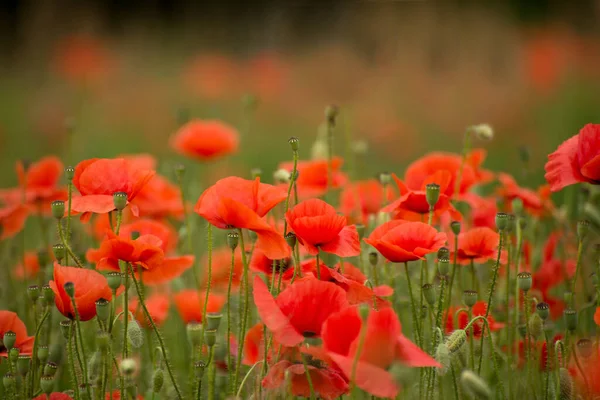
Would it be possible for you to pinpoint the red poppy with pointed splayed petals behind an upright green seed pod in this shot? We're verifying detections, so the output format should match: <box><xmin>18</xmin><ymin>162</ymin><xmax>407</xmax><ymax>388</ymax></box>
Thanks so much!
<box><xmin>381</xmin><ymin>171</ymin><xmax>462</xmax><ymax>221</ymax></box>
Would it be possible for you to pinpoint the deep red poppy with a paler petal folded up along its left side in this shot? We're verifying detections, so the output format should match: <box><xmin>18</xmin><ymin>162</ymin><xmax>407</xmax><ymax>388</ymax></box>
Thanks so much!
<box><xmin>254</xmin><ymin>277</ymin><xmax>348</xmax><ymax>347</ymax></box>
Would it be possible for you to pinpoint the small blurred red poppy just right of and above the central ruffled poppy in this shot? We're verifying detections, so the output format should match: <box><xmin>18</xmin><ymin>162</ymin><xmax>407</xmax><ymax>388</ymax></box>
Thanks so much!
<box><xmin>340</xmin><ymin>179</ymin><xmax>394</xmax><ymax>224</ymax></box>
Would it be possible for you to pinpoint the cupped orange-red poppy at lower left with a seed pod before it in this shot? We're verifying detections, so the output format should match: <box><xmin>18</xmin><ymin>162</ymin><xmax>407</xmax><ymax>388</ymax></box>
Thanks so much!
<box><xmin>49</xmin><ymin>263</ymin><xmax>112</xmax><ymax>321</ymax></box>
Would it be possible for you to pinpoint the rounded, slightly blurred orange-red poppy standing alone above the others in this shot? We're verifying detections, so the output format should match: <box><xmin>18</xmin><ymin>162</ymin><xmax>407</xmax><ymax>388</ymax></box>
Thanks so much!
<box><xmin>171</xmin><ymin>120</ymin><xmax>239</xmax><ymax>161</ymax></box>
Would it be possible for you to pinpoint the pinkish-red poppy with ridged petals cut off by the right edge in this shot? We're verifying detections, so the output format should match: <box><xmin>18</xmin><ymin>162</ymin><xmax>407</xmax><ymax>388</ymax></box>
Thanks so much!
<box><xmin>544</xmin><ymin>124</ymin><xmax>600</xmax><ymax>192</ymax></box>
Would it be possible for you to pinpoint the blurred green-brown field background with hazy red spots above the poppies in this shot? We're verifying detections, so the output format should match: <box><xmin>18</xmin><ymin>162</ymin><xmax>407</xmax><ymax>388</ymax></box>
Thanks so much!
<box><xmin>0</xmin><ymin>0</ymin><xmax>600</xmax><ymax>185</ymax></box>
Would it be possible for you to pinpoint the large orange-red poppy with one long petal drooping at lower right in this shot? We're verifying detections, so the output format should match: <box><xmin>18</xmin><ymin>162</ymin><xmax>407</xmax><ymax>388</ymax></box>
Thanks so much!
<box><xmin>194</xmin><ymin>176</ymin><xmax>290</xmax><ymax>259</ymax></box>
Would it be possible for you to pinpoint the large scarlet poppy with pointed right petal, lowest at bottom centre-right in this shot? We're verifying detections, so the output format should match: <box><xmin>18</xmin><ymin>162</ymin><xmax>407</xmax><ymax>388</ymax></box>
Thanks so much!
<box><xmin>323</xmin><ymin>307</ymin><xmax>440</xmax><ymax>397</ymax></box>
